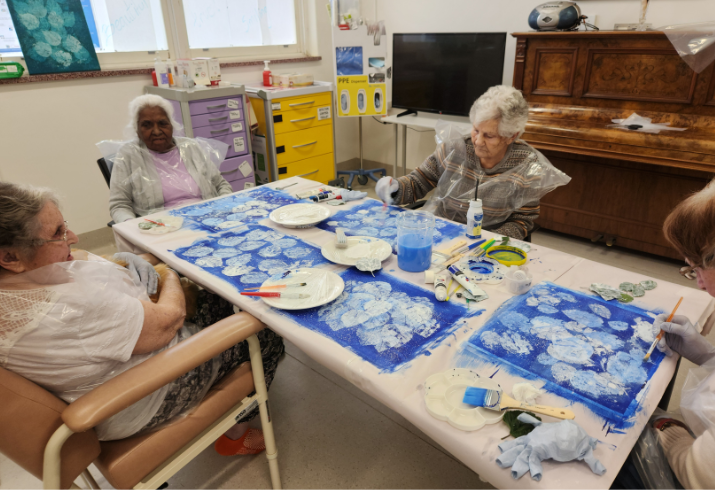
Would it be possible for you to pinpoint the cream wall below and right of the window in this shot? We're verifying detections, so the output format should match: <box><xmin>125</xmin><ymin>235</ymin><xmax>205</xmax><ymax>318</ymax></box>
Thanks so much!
<box><xmin>0</xmin><ymin>0</ymin><xmax>358</xmax><ymax>233</ymax></box>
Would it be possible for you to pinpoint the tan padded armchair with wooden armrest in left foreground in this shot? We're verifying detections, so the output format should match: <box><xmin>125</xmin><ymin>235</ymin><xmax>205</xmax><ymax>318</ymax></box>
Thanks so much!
<box><xmin>0</xmin><ymin>313</ymin><xmax>281</xmax><ymax>488</ymax></box>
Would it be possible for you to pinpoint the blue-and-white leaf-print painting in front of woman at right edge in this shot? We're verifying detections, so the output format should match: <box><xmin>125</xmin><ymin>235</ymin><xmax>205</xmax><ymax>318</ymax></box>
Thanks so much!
<box><xmin>456</xmin><ymin>282</ymin><xmax>664</xmax><ymax>427</ymax></box>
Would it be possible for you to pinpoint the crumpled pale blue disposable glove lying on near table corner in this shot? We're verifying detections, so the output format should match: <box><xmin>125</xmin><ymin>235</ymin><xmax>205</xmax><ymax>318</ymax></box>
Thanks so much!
<box><xmin>497</xmin><ymin>413</ymin><xmax>606</xmax><ymax>481</ymax></box>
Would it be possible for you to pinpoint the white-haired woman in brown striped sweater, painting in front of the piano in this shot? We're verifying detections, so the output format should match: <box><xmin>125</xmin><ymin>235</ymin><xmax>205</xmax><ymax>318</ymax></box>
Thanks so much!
<box><xmin>375</xmin><ymin>85</ymin><xmax>556</xmax><ymax>239</ymax></box>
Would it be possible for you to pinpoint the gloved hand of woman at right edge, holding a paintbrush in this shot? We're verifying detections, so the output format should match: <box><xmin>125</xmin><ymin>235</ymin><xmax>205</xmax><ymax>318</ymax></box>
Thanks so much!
<box><xmin>653</xmin><ymin>313</ymin><xmax>715</xmax><ymax>366</ymax></box>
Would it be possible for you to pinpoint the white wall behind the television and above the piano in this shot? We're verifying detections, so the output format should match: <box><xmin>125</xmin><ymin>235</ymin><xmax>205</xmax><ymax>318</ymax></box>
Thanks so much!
<box><xmin>364</xmin><ymin>0</ymin><xmax>715</xmax><ymax>171</ymax></box>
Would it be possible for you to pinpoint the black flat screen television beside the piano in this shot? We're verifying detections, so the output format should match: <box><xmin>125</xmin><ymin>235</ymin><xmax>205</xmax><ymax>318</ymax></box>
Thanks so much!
<box><xmin>392</xmin><ymin>32</ymin><xmax>506</xmax><ymax>116</ymax></box>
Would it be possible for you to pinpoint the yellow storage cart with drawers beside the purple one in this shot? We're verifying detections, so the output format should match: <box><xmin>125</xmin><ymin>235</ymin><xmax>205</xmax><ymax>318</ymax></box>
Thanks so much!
<box><xmin>246</xmin><ymin>82</ymin><xmax>335</xmax><ymax>184</ymax></box>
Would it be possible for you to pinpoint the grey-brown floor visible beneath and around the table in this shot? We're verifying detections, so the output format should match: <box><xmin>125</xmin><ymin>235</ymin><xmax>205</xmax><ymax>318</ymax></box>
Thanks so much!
<box><xmin>0</xmin><ymin>182</ymin><xmax>715</xmax><ymax>489</ymax></box>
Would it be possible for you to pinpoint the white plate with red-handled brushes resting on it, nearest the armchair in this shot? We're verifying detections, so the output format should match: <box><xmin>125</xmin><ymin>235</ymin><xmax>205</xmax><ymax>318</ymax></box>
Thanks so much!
<box><xmin>261</xmin><ymin>269</ymin><xmax>345</xmax><ymax>310</ymax></box>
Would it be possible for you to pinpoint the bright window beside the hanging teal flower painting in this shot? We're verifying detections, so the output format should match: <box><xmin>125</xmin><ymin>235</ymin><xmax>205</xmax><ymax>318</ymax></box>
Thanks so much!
<box><xmin>0</xmin><ymin>0</ymin><xmax>302</xmax><ymax>69</ymax></box>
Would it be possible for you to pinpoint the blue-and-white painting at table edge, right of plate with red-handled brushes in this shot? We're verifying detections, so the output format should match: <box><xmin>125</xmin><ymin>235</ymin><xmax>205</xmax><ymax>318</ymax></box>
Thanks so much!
<box><xmin>281</xmin><ymin>268</ymin><xmax>484</xmax><ymax>372</ymax></box>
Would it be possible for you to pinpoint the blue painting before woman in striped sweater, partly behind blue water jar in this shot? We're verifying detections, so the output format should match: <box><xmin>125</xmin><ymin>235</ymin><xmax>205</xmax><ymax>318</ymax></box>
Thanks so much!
<box><xmin>318</xmin><ymin>199</ymin><xmax>467</xmax><ymax>254</ymax></box>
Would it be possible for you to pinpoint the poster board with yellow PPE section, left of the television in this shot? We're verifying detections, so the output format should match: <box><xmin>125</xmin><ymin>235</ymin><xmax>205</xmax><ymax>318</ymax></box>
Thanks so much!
<box><xmin>333</xmin><ymin>24</ymin><xmax>387</xmax><ymax>117</ymax></box>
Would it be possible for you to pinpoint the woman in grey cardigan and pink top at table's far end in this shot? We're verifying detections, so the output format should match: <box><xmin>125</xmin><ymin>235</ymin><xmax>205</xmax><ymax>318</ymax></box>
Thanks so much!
<box><xmin>109</xmin><ymin>94</ymin><xmax>233</xmax><ymax>223</ymax></box>
